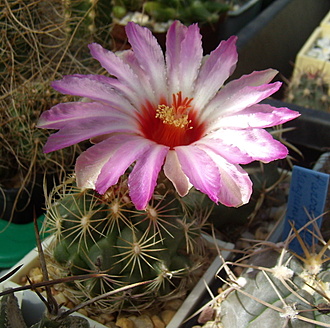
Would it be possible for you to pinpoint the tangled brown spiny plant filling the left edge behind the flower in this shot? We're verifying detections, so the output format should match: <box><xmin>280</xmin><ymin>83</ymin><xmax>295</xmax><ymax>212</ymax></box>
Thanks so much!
<box><xmin>0</xmin><ymin>0</ymin><xmax>114</xmax><ymax>220</ymax></box>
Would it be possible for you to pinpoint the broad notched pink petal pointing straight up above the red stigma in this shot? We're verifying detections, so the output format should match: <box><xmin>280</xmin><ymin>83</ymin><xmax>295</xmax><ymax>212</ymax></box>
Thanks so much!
<box><xmin>166</xmin><ymin>21</ymin><xmax>203</xmax><ymax>97</ymax></box>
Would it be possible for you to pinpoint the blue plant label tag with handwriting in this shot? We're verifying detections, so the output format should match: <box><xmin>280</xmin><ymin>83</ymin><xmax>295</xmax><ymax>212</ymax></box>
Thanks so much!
<box><xmin>283</xmin><ymin>166</ymin><xmax>329</xmax><ymax>254</ymax></box>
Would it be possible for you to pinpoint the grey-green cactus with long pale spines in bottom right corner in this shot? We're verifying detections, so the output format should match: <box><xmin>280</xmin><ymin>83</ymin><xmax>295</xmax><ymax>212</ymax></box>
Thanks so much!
<box><xmin>196</xmin><ymin>220</ymin><xmax>330</xmax><ymax>328</ymax></box>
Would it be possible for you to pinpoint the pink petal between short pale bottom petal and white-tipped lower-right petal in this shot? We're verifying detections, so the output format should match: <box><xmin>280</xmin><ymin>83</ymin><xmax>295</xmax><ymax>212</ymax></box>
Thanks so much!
<box><xmin>175</xmin><ymin>146</ymin><xmax>220</xmax><ymax>203</ymax></box>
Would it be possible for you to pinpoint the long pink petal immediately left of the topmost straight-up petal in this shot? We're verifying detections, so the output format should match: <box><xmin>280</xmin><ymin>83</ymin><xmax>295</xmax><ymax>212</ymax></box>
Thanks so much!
<box><xmin>125</xmin><ymin>22</ymin><xmax>167</xmax><ymax>98</ymax></box>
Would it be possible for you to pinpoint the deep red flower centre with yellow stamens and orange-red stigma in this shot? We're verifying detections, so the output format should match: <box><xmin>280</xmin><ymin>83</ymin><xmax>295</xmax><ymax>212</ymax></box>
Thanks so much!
<box><xmin>140</xmin><ymin>91</ymin><xmax>205</xmax><ymax>148</ymax></box>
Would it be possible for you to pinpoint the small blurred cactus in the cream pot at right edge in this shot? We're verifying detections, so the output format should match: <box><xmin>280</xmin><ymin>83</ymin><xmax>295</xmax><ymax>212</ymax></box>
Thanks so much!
<box><xmin>286</xmin><ymin>72</ymin><xmax>330</xmax><ymax>112</ymax></box>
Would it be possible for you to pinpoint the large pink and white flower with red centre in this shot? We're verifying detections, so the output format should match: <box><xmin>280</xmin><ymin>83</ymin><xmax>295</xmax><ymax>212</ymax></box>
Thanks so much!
<box><xmin>38</xmin><ymin>22</ymin><xmax>299</xmax><ymax>209</ymax></box>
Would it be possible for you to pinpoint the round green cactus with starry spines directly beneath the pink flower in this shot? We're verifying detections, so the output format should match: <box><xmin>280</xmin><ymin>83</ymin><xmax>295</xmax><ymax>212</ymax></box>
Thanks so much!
<box><xmin>45</xmin><ymin>176</ymin><xmax>210</xmax><ymax>314</ymax></box>
